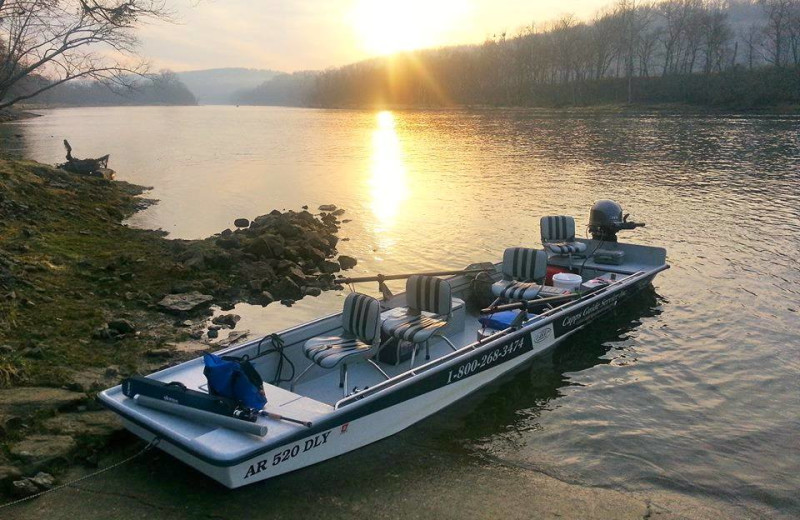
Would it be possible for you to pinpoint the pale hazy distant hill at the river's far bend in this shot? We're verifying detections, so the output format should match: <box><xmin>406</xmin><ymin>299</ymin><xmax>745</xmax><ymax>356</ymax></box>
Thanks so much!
<box><xmin>178</xmin><ymin>68</ymin><xmax>282</xmax><ymax>105</ymax></box>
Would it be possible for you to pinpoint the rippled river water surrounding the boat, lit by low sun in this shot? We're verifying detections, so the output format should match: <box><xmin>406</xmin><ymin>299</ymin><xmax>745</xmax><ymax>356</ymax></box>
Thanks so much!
<box><xmin>0</xmin><ymin>106</ymin><xmax>800</xmax><ymax>517</ymax></box>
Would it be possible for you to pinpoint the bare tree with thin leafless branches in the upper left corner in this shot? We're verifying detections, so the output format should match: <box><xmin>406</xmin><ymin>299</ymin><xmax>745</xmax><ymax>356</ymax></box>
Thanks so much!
<box><xmin>0</xmin><ymin>0</ymin><xmax>170</xmax><ymax>109</ymax></box>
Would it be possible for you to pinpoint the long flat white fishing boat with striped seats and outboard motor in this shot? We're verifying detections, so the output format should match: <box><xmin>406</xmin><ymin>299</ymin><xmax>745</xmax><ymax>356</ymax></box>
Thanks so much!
<box><xmin>99</xmin><ymin>200</ymin><xmax>669</xmax><ymax>488</ymax></box>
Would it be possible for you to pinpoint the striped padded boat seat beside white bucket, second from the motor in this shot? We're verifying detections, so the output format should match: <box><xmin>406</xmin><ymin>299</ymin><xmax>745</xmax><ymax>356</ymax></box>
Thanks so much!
<box><xmin>492</xmin><ymin>247</ymin><xmax>547</xmax><ymax>300</ymax></box>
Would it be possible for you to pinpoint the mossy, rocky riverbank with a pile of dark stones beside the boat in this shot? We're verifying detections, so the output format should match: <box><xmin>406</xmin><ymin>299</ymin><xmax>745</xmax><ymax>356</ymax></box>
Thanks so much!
<box><xmin>0</xmin><ymin>160</ymin><xmax>356</xmax><ymax>496</ymax></box>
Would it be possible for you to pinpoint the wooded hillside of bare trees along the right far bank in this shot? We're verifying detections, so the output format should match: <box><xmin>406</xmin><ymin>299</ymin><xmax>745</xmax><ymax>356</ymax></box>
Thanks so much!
<box><xmin>238</xmin><ymin>0</ymin><xmax>800</xmax><ymax>107</ymax></box>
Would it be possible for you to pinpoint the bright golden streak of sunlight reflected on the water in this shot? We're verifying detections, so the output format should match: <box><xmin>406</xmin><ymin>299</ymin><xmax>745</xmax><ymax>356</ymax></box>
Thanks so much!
<box><xmin>369</xmin><ymin>111</ymin><xmax>408</xmax><ymax>239</ymax></box>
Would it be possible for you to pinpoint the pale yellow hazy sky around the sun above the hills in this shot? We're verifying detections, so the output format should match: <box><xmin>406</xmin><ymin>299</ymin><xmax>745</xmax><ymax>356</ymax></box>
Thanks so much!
<box><xmin>141</xmin><ymin>0</ymin><xmax>612</xmax><ymax>72</ymax></box>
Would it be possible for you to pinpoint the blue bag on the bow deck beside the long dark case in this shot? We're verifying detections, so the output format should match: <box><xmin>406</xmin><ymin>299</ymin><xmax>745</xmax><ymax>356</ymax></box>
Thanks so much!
<box><xmin>203</xmin><ymin>354</ymin><xmax>267</xmax><ymax>410</ymax></box>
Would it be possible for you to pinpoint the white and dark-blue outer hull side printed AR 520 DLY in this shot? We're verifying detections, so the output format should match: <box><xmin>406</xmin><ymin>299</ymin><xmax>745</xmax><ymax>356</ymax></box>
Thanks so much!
<box><xmin>114</xmin><ymin>267</ymin><xmax>666</xmax><ymax>488</ymax></box>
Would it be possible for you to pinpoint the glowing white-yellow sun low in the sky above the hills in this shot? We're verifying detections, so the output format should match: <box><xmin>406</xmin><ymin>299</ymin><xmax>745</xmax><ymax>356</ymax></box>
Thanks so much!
<box><xmin>351</xmin><ymin>0</ymin><xmax>470</xmax><ymax>55</ymax></box>
